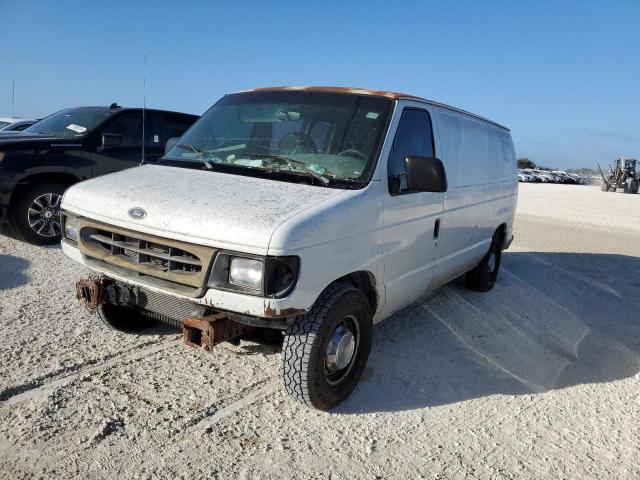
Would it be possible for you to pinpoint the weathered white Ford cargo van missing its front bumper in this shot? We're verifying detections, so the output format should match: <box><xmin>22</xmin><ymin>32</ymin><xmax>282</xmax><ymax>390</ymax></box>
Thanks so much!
<box><xmin>62</xmin><ymin>87</ymin><xmax>518</xmax><ymax>410</ymax></box>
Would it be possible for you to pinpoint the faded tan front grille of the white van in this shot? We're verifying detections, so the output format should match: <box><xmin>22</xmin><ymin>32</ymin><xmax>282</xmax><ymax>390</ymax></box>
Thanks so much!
<box><xmin>78</xmin><ymin>219</ymin><xmax>215</xmax><ymax>297</ymax></box>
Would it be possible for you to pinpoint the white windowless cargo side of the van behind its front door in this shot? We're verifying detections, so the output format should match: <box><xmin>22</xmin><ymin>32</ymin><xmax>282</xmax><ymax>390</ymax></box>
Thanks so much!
<box><xmin>436</xmin><ymin>108</ymin><xmax>517</xmax><ymax>285</ymax></box>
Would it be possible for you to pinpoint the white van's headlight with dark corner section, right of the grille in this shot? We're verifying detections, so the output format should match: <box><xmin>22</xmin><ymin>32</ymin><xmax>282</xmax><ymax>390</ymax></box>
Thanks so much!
<box><xmin>207</xmin><ymin>252</ymin><xmax>300</xmax><ymax>298</ymax></box>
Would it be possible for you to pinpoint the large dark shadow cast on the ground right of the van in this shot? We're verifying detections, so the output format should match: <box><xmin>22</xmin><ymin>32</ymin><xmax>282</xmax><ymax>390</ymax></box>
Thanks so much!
<box><xmin>335</xmin><ymin>252</ymin><xmax>640</xmax><ymax>413</ymax></box>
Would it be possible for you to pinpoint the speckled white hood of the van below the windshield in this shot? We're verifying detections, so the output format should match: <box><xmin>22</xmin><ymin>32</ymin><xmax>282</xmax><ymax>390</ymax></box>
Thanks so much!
<box><xmin>62</xmin><ymin>165</ymin><xmax>344</xmax><ymax>254</ymax></box>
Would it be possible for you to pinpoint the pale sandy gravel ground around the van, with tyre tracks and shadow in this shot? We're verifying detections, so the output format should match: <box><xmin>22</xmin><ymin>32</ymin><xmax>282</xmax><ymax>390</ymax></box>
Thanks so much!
<box><xmin>0</xmin><ymin>185</ymin><xmax>640</xmax><ymax>479</ymax></box>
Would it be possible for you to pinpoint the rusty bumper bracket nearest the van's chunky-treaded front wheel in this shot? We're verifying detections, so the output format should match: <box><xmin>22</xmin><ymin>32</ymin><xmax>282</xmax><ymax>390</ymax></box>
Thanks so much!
<box><xmin>182</xmin><ymin>313</ymin><xmax>253</xmax><ymax>352</ymax></box>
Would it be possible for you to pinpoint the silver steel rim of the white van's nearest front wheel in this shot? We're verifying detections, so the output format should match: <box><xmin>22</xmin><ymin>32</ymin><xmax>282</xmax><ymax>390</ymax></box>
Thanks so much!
<box><xmin>324</xmin><ymin>315</ymin><xmax>360</xmax><ymax>386</ymax></box>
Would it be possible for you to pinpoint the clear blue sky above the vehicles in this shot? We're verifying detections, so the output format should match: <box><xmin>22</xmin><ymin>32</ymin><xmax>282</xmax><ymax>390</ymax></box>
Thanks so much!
<box><xmin>0</xmin><ymin>0</ymin><xmax>640</xmax><ymax>168</ymax></box>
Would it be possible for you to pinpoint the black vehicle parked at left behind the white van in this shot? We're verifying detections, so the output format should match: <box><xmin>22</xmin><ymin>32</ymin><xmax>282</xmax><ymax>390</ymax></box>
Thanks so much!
<box><xmin>0</xmin><ymin>104</ymin><xmax>198</xmax><ymax>245</ymax></box>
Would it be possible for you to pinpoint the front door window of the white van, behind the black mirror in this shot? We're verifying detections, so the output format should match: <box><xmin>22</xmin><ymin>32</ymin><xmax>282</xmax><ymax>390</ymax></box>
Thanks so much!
<box><xmin>387</xmin><ymin>108</ymin><xmax>434</xmax><ymax>195</ymax></box>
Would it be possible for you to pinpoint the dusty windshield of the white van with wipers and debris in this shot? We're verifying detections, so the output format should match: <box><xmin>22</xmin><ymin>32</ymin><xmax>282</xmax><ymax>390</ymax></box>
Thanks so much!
<box><xmin>164</xmin><ymin>91</ymin><xmax>391</xmax><ymax>188</ymax></box>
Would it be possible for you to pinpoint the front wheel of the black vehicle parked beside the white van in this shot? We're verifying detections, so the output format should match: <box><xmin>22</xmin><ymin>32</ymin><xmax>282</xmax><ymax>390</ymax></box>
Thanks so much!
<box><xmin>9</xmin><ymin>183</ymin><xmax>67</xmax><ymax>245</ymax></box>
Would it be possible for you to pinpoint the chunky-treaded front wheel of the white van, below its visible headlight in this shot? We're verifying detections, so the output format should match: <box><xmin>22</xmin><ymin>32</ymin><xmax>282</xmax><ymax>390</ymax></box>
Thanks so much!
<box><xmin>282</xmin><ymin>283</ymin><xmax>373</xmax><ymax>410</ymax></box>
